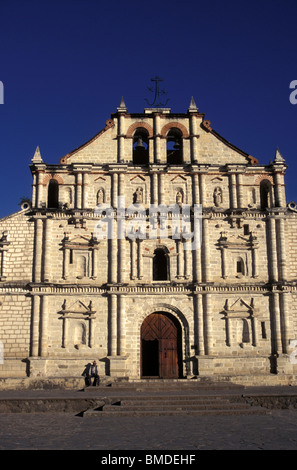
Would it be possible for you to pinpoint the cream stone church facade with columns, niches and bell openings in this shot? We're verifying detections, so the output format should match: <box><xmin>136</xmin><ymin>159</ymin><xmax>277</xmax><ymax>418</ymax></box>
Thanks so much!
<box><xmin>0</xmin><ymin>98</ymin><xmax>297</xmax><ymax>386</ymax></box>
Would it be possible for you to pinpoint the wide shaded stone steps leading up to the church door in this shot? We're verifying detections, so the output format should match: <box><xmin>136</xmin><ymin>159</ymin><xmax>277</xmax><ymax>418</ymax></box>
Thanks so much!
<box><xmin>83</xmin><ymin>380</ymin><xmax>269</xmax><ymax>417</ymax></box>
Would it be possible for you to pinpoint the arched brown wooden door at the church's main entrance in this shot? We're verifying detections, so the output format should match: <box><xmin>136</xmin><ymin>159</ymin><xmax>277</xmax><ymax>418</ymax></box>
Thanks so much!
<box><xmin>141</xmin><ymin>312</ymin><xmax>182</xmax><ymax>379</ymax></box>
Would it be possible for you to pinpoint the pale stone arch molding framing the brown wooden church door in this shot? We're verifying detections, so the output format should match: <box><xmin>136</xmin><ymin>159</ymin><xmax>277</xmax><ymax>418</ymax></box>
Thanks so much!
<box><xmin>138</xmin><ymin>302</ymin><xmax>193</xmax><ymax>375</ymax></box>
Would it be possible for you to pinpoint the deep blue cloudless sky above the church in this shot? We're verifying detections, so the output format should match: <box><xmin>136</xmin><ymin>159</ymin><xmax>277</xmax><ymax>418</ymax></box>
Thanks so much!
<box><xmin>0</xmin><ymin>0</ymin><xmax>297</xmax><ymax>217</ymax></box>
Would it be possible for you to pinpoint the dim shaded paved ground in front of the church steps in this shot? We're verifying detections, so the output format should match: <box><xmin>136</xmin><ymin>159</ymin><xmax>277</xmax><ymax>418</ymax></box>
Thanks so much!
<box><xmin>0</xmin><ymin>409</ymin><xmax>297</xmax><ymax>451</ymax></box>
